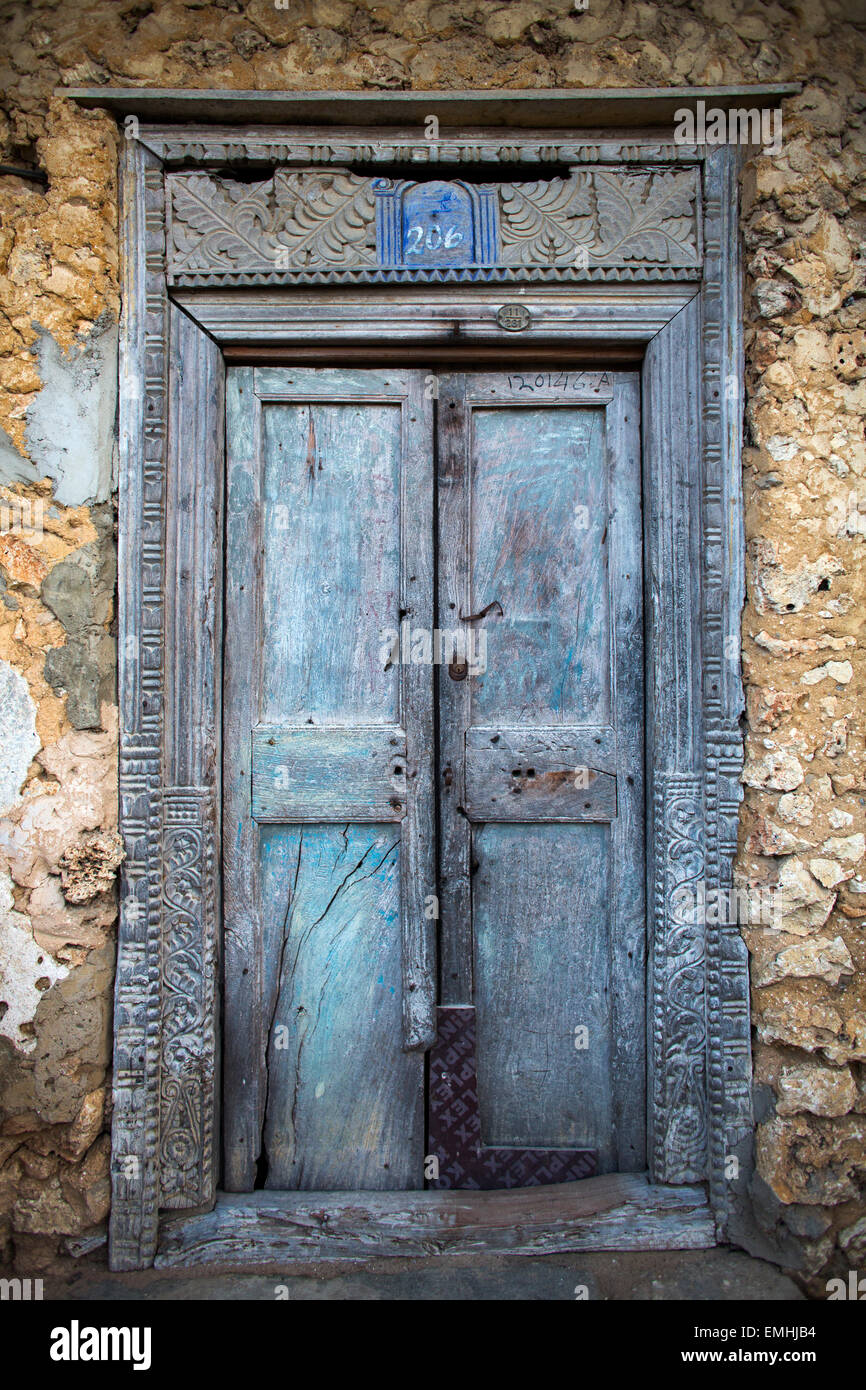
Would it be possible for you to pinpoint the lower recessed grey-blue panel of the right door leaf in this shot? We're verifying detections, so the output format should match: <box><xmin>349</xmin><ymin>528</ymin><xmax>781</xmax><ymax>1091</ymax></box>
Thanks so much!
<box><xmin>473</xmin><ymin>824</ymin><xmax>612</xmax><ymax>1165</ymax></box>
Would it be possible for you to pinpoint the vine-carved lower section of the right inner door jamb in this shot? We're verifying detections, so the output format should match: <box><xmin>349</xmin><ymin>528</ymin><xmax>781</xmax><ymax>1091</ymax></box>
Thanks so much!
<box><xmin>652</xmin><ymin>773</ymin><xmax>708</xmax><ymax>1183</ymax></box>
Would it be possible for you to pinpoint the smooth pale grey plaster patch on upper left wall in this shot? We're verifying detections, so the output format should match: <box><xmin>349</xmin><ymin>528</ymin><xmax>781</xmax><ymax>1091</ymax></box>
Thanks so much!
<box><xmin>25</xmin><ymin>314</ymin><xmax>117</xmax><ymax>507</ymax></box>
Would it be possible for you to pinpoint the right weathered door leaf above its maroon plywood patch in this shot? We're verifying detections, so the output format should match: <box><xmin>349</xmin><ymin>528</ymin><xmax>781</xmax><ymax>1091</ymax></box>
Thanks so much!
<box><xmin>438</xmin><ymin>371</ymin><xmax>646</xmax><ymax>1180</ymax></box>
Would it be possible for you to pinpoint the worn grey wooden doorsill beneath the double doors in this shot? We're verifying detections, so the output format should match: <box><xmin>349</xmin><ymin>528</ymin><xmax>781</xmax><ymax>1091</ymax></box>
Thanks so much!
<box><xmin>156</xmin><ymin>1173</ymin><xmax>716</xmax><ymax>1269</ymax></box>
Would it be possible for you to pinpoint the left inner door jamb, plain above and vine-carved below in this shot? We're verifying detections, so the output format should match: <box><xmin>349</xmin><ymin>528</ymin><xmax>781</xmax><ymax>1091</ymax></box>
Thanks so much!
<box><xmin>160</xmin><ymin>306</ymin><xmax>225</xmax><ymax>1207</ymax></box>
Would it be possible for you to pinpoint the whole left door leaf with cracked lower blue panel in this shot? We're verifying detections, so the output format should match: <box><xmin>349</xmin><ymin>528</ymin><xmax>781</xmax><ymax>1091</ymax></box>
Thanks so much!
<box><xmin>224</xmin><ymin>368</ymin><xmax>435</xmax><ymax>1191</ymax></box>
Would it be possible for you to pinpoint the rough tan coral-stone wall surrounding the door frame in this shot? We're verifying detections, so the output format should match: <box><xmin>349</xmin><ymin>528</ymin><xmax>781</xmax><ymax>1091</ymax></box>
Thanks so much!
<box><xmin>0</xmin><ymin>0</ymin><xmax>866</xmax><ymax>1291</ymax></box>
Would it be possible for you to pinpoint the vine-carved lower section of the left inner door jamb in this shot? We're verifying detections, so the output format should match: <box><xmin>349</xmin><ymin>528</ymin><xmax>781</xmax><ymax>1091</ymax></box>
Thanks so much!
<box><xmin>160</xmin><ymin>787</ymin><xmax>217</xmax><ymax>1207</ymax></box>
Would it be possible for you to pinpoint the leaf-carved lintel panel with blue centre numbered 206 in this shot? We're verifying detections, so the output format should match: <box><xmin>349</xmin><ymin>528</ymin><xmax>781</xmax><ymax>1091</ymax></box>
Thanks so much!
<box><xmin>167</xmin><ymin>168</ymin><xmax>701</xmax><ymax>286</ymax></box>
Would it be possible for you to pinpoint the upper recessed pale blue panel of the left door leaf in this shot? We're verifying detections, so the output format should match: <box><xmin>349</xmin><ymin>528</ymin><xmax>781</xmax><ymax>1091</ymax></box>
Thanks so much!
<box><xmin>260</xmin><ymin>400</ymin><xmax>403</xmax><ymax>724</ymax></box>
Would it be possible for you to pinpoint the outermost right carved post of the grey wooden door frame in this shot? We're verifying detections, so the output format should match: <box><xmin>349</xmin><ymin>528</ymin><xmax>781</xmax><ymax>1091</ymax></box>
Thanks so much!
<box><xmin>702</xmin><ymin>147</ymin><xmax>752</xmax><ymax>1237</ymax></box>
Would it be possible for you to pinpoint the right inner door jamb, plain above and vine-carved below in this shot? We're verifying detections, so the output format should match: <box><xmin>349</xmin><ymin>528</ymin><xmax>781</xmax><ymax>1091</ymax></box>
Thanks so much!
<box><xmin>644</xmin><ymin>299</ymin><xmax>708</xmax><ymax>1183</ymax></box>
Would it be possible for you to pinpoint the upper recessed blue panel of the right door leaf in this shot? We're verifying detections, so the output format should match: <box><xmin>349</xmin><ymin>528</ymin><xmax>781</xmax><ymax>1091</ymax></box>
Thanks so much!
<box><xmin>468</xmin><ymin>406</ymin><xmax>610</xmax><ymax>726</ymax></box>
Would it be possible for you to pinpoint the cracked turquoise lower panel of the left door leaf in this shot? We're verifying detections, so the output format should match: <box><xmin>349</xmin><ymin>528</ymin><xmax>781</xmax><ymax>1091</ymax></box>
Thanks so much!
<box><xmin>260</xmin><ymin>824</ymin><xmax>424</xmax><ymax>1191</ymax></box>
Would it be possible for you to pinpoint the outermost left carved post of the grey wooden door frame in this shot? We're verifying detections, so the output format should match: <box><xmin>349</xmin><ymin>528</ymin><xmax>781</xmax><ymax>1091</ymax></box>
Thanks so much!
<box><xmin>111</xmin><ymin>140</ymin><xmax>168</xmax><ymax>1269</ymax></box>
